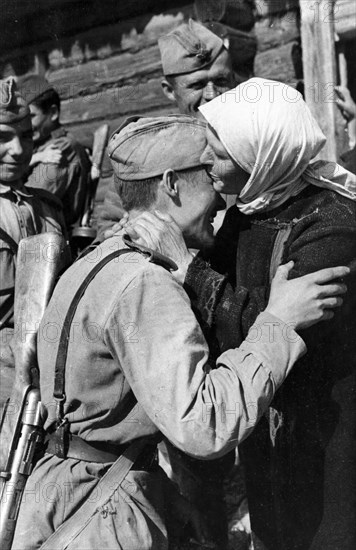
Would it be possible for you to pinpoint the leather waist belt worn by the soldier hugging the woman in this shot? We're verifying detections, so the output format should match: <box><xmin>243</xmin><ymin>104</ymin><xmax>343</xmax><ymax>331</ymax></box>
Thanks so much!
<box><xmin>45</xmin><ymin>434</ymin><xmax>158</xmax><ymax>471</ymax></box>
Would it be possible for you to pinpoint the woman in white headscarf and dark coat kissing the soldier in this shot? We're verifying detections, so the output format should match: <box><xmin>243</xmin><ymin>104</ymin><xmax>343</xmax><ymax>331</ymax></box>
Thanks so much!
<box><xmin>120</xmin><ymin>78</ymin><xmax>356</xmax><ymax>550</ymax></box>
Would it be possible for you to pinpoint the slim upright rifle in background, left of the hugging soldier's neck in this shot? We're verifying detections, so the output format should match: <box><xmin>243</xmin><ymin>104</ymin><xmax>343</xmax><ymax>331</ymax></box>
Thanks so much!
<box><xmin>72</xmin><ymin>124</ymin><xmax>109</xmax><ymax>252</ymax></box>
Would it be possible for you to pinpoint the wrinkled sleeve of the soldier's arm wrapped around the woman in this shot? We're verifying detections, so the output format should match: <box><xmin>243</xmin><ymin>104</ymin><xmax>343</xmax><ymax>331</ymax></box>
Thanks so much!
<box><xmin>105</xmin><ymin>266</ymin><xmax>305</xmax><ymax>459</ymax></box>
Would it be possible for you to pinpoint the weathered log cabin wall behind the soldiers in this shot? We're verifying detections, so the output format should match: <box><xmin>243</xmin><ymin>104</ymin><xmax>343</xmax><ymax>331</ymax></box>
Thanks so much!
<box><xmin>0</xmin><ymin>0</ymin><xmax>301</xmax><ymax>150</ymax></box>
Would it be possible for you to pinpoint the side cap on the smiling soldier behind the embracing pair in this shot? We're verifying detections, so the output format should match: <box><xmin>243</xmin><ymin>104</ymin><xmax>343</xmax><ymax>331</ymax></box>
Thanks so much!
<box><xmin>158</xmin><ymin>19</ymin><xmax>224</xmax><ymax>76</ymax></box>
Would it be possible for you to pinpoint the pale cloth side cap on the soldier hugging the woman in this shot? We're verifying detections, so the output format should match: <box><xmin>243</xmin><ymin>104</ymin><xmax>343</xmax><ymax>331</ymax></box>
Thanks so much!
<box><xmin>107</xmin><ymin>115</ymin><xmax>206</xmax><ymax>181</ymax></box>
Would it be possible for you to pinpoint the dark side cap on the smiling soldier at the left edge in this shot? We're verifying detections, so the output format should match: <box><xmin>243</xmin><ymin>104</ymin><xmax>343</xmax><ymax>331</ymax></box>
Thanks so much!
<box><xmin>0</xmin><ymin>77</ymin><xmax>30</xmax><ymax>124</ymax></box>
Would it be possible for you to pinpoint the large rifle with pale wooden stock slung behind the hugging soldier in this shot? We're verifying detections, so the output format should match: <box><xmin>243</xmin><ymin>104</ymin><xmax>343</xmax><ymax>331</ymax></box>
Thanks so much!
<box><xmin>0</xmin><ymin>233</ymin><xmax>69</xmax><ymax>550</ymax></box>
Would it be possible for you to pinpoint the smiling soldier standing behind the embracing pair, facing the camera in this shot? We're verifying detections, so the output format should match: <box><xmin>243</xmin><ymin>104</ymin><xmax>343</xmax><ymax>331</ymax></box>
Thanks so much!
<box><xmin>94</xmin><ymin>19</ymin><xmax>245</xmax><ymax>549</ymax></box>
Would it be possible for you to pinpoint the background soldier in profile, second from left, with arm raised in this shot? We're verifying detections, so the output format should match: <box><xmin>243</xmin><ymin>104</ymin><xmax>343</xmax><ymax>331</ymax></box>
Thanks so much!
<box><xmin>19</xmin><ymin>75</ymin><xmax>90</xmax><ymax>233</ymax></box>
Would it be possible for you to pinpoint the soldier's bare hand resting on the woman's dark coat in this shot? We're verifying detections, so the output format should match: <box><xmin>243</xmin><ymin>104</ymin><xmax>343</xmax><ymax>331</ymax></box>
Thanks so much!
<box><xmin>266</xmin><ymin>262</ymin><xmax>350</xmax><ymax>330</ymax></box>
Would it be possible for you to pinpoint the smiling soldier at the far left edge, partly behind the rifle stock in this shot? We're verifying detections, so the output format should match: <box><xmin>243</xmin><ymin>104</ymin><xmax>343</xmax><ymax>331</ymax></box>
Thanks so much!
<box><xmin>0</xmin><ymin>78</ymin><xmax>64</xmax><ymax>402</ymax></box>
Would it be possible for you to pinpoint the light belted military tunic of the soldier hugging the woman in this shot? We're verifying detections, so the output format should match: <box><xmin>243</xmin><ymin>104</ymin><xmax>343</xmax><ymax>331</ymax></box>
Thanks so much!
<box><xmin>14</xmin><ymin>236</ymin><xmax>305</xmax><ymax>550</ymax></box>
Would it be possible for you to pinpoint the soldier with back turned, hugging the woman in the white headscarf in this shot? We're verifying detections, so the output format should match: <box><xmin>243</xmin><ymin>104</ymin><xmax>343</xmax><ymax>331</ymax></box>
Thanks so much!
<box><xmin>13</xmin><ymin>115</ymin><xmax>348</xmax><ymax>550</ymax></box>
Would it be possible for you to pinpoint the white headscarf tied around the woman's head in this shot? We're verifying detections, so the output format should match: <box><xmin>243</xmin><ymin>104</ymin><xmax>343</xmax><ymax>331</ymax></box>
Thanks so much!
<box><xmin>199</xmin><ymin>78</ymin><xmax>356</xmax><ymax>214</ymax></box>
